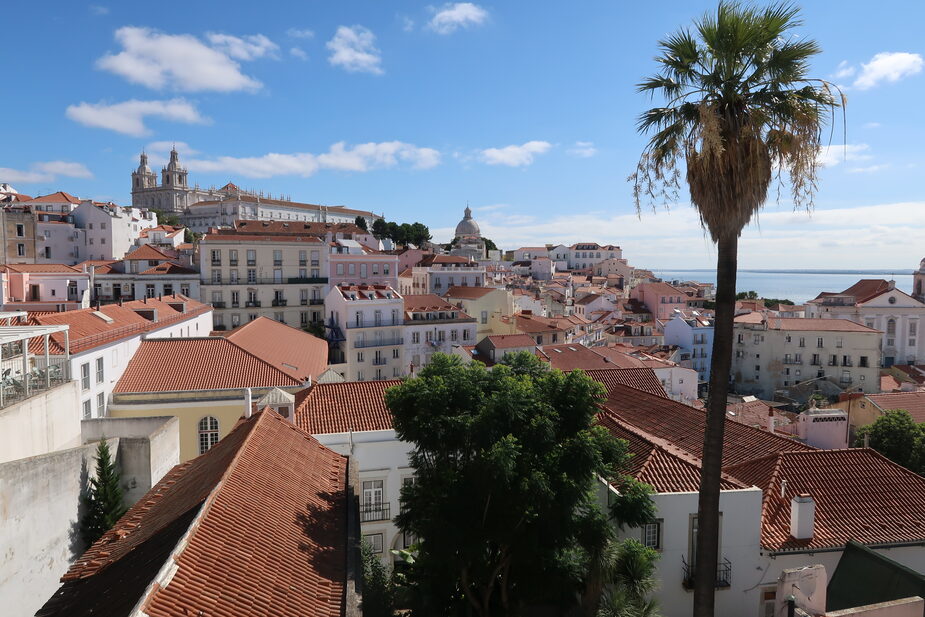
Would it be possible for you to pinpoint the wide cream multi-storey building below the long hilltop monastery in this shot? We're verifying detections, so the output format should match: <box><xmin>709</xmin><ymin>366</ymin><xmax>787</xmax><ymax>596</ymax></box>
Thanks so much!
<box><xmin>199</xmin><ymin>230</ymin><xmax>328</xmax><ymax>330</ymax></box>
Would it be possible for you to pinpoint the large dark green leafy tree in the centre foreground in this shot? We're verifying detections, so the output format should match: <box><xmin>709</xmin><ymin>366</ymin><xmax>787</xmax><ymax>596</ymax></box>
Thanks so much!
<box><xmin>386</xmin><ymin>353</ymin><xmax>651</xmax><ymax>615</ymax></box>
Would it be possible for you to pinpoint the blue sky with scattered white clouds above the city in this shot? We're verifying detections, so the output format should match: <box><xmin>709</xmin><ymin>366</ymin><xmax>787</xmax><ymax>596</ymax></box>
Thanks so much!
<box><xmin>0</xmin><ymin>0</ymin><xmax>925</xmax><ymax>268</ymax></box>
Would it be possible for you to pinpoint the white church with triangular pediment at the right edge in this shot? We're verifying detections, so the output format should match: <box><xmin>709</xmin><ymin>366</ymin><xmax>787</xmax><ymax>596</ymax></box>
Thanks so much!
<box><xmin>806</xmin><ymin>279</ymin><xmax>925</xmax><ymax>366</ymax></box>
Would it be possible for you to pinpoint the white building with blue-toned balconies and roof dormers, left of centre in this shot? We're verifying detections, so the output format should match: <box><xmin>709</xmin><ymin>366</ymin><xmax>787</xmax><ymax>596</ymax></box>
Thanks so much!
<box><xmin>324</xmin><ymin>285</ymin><xmax>405</xmax><ymax>381</ymax></box>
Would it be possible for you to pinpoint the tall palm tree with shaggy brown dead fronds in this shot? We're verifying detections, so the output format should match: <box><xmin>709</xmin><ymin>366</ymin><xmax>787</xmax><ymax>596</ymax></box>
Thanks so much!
<box><xmin>630</xmin><ymin>1</ymin><xmax>844</xmax><ymax>617</ymax></box>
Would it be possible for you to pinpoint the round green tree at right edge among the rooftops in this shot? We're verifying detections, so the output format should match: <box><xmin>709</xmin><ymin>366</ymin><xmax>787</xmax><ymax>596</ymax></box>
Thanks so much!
<box><xmin>854</xmin><ymin>409</ymin><xmax>925</xmax><ymax>474</ymax></box>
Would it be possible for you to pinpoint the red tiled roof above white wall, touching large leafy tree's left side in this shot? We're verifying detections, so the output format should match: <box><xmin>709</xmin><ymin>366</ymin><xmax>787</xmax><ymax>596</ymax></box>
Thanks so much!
<box><xmin>295</xmin><ymin>379</ymin><xmax>401</xmax><ymax>435</ymax></box>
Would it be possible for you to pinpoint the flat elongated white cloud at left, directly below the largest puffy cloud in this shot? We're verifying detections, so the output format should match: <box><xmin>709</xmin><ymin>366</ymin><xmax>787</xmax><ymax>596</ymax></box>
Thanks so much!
<box><xmin>65</xmin><ymin>99</ymin><xmax>209</xmax><ymax>137</ymax></box>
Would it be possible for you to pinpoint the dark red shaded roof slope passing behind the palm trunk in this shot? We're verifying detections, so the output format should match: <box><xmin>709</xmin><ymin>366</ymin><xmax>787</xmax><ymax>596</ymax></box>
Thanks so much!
<box><xmin>592</xmin><ymin>382</ymin><xmax>814</xmax><ymax>464</ymax></box>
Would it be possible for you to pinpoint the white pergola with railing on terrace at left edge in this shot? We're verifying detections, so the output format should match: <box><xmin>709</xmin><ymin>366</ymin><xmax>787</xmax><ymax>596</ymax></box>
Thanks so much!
<box><xmin>0</xmin><ymin>318</ymin><xmax>71</xmax><ymax>408</ymax></box>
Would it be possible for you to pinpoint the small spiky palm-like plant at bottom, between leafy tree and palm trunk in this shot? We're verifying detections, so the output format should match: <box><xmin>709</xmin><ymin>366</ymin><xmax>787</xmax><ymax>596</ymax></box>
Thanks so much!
<box><xmin>597</xmin><ymin>540</ymin><xmax>660</xmax><ymax>617</ymax></box>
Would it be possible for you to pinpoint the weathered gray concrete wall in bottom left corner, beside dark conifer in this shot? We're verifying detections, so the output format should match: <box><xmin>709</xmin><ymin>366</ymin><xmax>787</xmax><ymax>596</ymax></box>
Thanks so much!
<box><xmin>0</xmin><ymin>439</ymin><xmax>119</xmax><ymax>616</ymax></box>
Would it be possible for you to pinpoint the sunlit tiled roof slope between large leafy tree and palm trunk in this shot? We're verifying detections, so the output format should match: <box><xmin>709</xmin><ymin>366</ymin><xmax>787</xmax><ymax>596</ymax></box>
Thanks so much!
<box><xmin>597</xmin><ymin>411</ymin><xmax>748</xmax><ymax>493</ymax></box>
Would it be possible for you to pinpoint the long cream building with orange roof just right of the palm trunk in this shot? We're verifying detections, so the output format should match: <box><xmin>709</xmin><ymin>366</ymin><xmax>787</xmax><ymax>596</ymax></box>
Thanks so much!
<box><xmin>732</xmin><ymin>313</ymin><xmax>881</xmax><ymax>400</ymax></box>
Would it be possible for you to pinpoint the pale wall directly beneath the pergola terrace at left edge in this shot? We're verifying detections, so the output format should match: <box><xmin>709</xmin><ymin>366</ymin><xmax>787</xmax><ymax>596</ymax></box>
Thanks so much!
<box><xmin>0</xmin><ymin>381</ymin><xmax>82</xmax><ymax>463</ymax></box>
